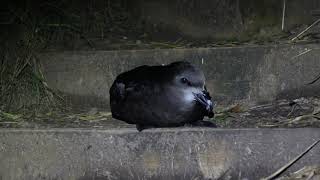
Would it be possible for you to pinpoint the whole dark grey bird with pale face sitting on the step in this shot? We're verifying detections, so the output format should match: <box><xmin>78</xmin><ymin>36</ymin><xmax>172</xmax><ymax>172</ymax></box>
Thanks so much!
<box><xmin>109</xmin><ymin>61</ymin><xmax>215</xmax><ymax>131</ymax></box>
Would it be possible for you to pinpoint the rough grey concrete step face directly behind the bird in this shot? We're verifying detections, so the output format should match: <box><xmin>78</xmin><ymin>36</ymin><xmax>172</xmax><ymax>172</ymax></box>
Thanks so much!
<box><xmin>39</xmin><ymin>44</ymin><xmax>320</xmax><ymax>108</ymax></box>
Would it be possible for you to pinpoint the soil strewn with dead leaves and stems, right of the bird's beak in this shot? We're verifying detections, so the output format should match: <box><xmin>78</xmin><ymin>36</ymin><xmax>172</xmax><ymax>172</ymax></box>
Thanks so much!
<box><xmin>215</xmin><ymin>98</ymin><xmax>320</xmax><ymax>128</ymax></box>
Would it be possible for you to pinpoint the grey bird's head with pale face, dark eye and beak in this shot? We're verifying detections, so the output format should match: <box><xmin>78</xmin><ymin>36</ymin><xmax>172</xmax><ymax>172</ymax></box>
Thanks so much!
<box><xmin>169</xmin><ymin>61</ymin><xmax>213</xmax><ymax>117</ymax></box>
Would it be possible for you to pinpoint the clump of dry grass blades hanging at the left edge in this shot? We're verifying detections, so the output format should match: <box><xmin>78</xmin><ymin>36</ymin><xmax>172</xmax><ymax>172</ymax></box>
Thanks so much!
<box><xmin>0</xmin><ymin>35</ymin><xmax>57</xmax><ymax>111</ymax></box>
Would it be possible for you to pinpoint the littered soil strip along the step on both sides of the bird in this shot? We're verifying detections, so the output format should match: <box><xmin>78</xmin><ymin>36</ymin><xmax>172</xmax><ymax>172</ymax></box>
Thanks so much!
<box><xmin>0</xmin><ymin>97</ymin><xmax>320</xmax><ymax>129</ymax></box>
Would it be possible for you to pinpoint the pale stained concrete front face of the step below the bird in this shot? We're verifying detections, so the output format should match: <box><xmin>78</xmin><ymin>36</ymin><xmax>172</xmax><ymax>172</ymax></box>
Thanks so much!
<box><xmin>0</xmin><ymin>128</ymin><xmax>320</xmax><ymax>180</ymax></box>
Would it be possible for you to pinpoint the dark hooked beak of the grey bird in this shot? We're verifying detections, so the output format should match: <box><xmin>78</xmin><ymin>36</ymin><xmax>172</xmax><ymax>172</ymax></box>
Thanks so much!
<box><xmin>193</xmin><ymin>90</ymin><xmax>214</xmax><ymax>118</ymax></box>
